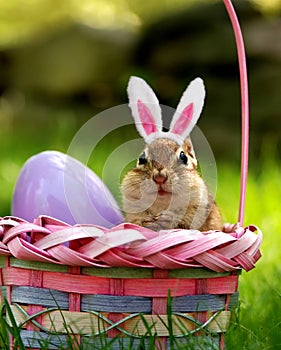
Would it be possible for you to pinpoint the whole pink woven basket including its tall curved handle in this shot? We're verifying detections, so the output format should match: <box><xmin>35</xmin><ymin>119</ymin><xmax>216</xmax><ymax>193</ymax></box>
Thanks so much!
<box><xmin>0</xmin><ymin>0</ymin><xmax>262</xmax><ymax>349</ymax></box>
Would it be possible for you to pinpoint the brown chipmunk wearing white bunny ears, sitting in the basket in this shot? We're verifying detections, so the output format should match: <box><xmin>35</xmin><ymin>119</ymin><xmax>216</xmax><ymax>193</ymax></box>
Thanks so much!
<box><xmin>121</xmin><ymin>77</ymin><xmax>222</xmax><ymax>231</ymax></box>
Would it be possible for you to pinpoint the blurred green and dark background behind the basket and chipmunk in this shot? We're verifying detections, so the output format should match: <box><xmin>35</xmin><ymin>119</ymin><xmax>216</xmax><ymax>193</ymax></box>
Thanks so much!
<box><xmin>0</xmin><ymin>0</ymin><xmax>281</xmax><ymax>350</ymax></box>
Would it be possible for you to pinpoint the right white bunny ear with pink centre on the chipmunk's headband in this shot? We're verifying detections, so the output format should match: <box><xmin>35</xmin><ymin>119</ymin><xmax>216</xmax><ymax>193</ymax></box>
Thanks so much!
<box><xmin>169</xmin><ymin>78</ymin><xmax>205</xmax><ymax>141</ymax></box>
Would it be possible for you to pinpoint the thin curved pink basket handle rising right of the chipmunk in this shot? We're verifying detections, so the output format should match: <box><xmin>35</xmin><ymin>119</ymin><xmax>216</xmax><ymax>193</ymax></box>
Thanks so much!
<box><xmin>223</xmin><ymin>0</ymin><xmax>249</xmax><ymax>226</ymax></box>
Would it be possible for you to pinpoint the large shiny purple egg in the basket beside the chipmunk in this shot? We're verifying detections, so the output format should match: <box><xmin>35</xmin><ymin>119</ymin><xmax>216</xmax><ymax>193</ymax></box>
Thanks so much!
<box><xmin>12</xmin><ymin>151</ymin><xmax>123</xmax><ymax>227</ymax></box>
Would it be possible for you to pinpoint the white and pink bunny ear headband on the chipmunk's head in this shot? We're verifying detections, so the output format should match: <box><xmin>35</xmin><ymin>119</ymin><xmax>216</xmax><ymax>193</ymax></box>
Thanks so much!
<box><xmin>128</xmin><ymin>77</ymin><xmax>205</xmax><ymax>145</ymax></box>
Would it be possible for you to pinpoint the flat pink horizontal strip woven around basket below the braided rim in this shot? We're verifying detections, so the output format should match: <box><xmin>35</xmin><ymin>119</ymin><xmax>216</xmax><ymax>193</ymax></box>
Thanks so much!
<box><xmin>2</xmin><ymin>267</ymin><xmax>238</xmax><ymax>298</ymax></box>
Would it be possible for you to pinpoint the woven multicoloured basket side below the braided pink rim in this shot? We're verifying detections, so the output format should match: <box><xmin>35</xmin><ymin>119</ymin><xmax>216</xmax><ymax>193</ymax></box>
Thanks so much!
<box><xmin>2</xmin><ymin>257</ymin><xmax>239</xmax><ymax>349</ymax></box>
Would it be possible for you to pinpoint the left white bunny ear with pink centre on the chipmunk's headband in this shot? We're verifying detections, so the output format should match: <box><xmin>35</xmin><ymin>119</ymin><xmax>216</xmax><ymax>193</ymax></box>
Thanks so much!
<box><xmin>127</xmin><ymin>77</ymin><xmax>163</xmax><ymax>143</ymax></box>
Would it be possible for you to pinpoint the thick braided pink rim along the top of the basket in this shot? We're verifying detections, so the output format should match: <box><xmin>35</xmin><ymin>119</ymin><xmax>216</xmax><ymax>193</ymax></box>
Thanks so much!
<box><xmin>0</xmin><ymin>216</ymin><xmax>262</xmax><ymax>272</ymax></box>
